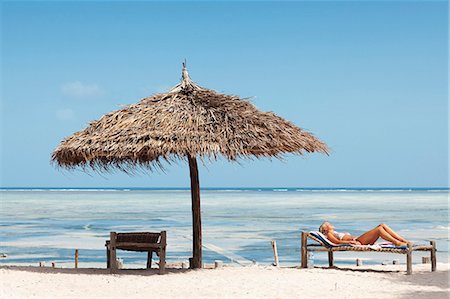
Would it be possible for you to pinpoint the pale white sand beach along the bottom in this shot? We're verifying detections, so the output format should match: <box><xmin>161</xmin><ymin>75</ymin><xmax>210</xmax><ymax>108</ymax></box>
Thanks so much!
<box><xmin>0</xmin><ymin>263</ymin><xmax>450</xmax><ymax>299</ymax></box>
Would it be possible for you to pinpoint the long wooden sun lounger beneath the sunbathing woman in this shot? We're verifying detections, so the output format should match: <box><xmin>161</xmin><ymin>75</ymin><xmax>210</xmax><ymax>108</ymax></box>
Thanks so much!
<box><xmin>301</xmin><ymin>232</ymin><xmax>436</xmax><ymax>275</ymax></box>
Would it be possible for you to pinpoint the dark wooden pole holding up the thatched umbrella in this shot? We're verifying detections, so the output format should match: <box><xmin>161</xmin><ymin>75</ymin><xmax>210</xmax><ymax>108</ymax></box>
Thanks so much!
<box><xmin>188</xmin><ymin>155</ymin><xmax>202</xmax><ymax>269</ymax></box>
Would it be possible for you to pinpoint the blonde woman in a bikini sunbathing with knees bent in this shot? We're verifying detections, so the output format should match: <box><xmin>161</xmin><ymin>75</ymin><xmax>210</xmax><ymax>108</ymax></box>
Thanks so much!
<box><xmin>319</xmin><ymin>222</ymin><xmax>411</xmax><ymax>246</ymax></box>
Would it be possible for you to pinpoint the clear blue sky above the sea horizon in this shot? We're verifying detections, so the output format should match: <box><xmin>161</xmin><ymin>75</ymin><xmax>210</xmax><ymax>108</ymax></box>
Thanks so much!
<box><xmin>0</xmin><ymin>1</ymin><xmax>448</xmax><ymax>187</ymax></box>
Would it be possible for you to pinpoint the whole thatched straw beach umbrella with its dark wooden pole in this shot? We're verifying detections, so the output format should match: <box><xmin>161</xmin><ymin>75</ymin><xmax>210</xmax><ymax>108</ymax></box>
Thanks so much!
<box><xmin>52</xmin><ymin>64</ymin><xmax>328</xmax><ymax>268</ymax></box>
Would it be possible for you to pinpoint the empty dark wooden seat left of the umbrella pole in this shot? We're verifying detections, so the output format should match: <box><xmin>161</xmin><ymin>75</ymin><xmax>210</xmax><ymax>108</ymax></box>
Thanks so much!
<box><xmin>105</xmin><ymin>231</ymin><xmax>167</xmax><ymax>274</ymax></box>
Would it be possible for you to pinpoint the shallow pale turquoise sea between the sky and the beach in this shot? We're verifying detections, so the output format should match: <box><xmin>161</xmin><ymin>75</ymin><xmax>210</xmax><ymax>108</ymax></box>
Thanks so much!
<box><xmin>0</xmin><ymin>188</ymin><xmax>450</xmax><ymax>268</ymax></box>
